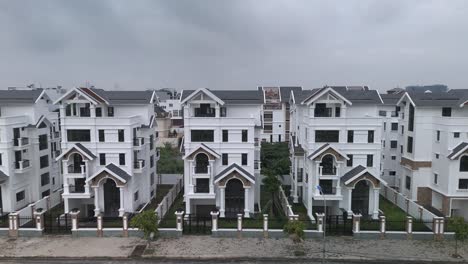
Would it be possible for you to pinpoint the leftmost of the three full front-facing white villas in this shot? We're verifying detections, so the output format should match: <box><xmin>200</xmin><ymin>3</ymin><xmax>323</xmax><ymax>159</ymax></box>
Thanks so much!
<box><xmin>55</xmin><ymin>88</ymin><xmax>158</xmax><ymax>216</ymax></box>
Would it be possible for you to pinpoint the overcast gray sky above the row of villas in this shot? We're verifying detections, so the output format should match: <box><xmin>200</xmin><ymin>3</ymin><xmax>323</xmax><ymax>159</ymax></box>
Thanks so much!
<box><xmin>0</xmin><ymin>0</ymin><xmax>468</xmax><ymax>91</ymax></box>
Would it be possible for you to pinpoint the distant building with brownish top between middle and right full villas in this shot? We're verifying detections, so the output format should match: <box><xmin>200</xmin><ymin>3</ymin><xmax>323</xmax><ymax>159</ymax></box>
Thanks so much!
<box><xmin>258</xmin><ymin>86</ymin><xmax>302</xmax><ymax>142</ymax></box>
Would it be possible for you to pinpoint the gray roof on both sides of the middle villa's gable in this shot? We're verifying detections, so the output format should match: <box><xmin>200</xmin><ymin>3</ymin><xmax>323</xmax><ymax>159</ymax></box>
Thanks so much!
<box><xmin>180</xmin><ymin>89</ymin><xmax>263</xmax><ymax>104</ymax></box>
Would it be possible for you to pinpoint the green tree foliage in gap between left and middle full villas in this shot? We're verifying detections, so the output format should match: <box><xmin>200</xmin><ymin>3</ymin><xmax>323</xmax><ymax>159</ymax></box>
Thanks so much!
<box><xmin>157</xmin><ymin>143</ymin><xmax>184</xmax><ymax>174</ymax></box>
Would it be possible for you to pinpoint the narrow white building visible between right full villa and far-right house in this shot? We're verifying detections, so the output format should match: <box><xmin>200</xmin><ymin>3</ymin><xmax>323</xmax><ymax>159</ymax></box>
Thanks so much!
<box><xmin>378</xmin><ymin>93</ymin><xmax>403</xmax><ymax>189</ymax></box>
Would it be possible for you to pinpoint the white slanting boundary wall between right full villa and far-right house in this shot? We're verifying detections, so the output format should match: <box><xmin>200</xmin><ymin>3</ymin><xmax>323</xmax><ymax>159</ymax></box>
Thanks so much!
<box><xmin>381</xmin><ymin>186</ymin><xmax>437</xmax><ymax>230</ymax></box>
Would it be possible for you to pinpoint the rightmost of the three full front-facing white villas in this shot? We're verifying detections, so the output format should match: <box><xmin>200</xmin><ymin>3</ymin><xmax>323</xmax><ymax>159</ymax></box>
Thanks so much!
<box><xmin>290</xmin><ymin>86</ymin><xmax>386</xmax><ymax>218</ymax></box>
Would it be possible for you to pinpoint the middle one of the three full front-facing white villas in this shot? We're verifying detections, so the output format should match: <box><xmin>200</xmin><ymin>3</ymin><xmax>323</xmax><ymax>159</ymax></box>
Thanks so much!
<box><xmin>181</xmin><ymin>88</ymin><xmax>263</xmax><ymax>217</ymax></box>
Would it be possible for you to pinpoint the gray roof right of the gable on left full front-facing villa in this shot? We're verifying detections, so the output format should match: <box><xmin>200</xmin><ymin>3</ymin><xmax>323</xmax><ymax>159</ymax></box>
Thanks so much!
<box><xmin>90</xmin><ymin>88</ymin><xmax>153</xmax><ymax>105</ymax></box>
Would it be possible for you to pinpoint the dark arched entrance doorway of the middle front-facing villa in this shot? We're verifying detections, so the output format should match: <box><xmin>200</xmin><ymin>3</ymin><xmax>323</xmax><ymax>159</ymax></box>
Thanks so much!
<box><xmin>225</xmin><ymin>179</ymin><xmax>244</xmax><ymax>217</ymax></box>
